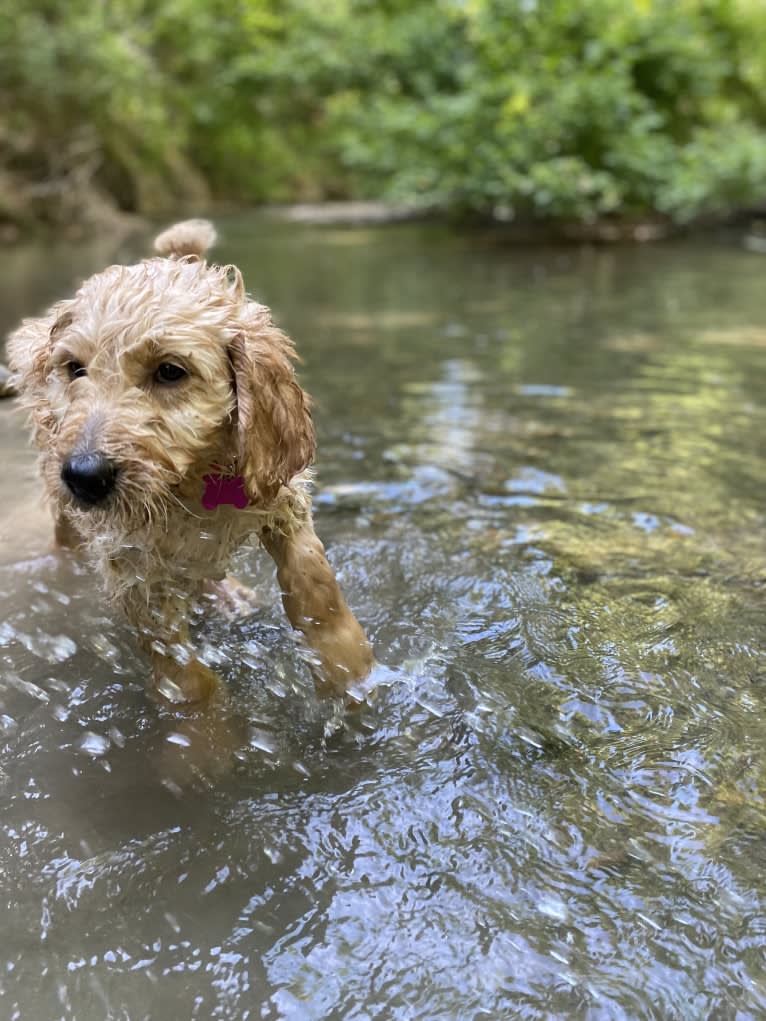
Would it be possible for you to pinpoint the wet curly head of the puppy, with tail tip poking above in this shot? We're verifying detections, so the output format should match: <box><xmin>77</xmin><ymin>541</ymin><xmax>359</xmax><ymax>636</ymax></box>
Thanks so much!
<box><xmin>8</xmin><ymin>221</ymin><xmax>315</xmax><ymax>523</ymax></box>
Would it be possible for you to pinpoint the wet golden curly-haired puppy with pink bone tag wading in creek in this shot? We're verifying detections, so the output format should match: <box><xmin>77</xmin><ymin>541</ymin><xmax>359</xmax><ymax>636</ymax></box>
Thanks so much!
<box><xmin>8</xmin><ymin>221</ymin><xmax>373</xmax><ymax>702</ymax></box>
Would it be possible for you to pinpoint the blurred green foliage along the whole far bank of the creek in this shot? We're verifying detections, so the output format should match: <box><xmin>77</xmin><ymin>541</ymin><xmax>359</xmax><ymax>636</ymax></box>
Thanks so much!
<box><xmin>0</xmin><ymin>0</ymin><xmax>766</xmax><ymax>230</ymax></box>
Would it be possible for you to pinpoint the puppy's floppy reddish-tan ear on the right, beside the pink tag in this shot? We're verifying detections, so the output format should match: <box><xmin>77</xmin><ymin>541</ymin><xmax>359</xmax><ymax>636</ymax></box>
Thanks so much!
<box><xmin>229</xmin><ymin>309</ymin><xmax>316</xmax><ymax>504</ymax></box>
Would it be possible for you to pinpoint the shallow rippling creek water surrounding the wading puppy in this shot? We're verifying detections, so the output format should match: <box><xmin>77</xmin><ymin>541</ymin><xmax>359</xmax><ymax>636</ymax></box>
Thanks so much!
<box><xmin>0</xmin><ymin>211</ymin><xmax>766</xmax><ymax>1021</ymax></box>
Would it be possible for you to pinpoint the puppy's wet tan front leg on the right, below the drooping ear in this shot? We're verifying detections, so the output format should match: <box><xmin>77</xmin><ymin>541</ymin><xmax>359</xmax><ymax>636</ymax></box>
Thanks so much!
<box><xmin>261</xmin><ymin>521</ymin><xmax>374</xmax><ymax>694</ymax></box>
